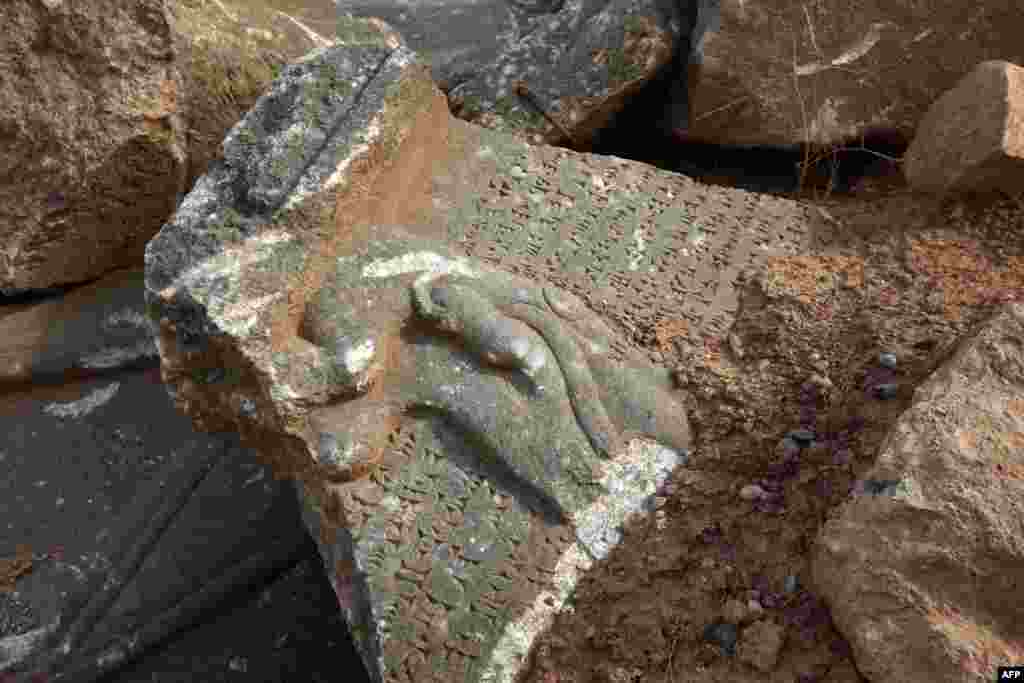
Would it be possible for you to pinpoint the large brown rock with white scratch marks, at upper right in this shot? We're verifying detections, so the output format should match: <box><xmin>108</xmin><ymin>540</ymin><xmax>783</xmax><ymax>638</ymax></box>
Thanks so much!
<box><xmin>692</xmin><ymin>0</ymin><xmax>1024</xmax><ymax>142</ymax></box>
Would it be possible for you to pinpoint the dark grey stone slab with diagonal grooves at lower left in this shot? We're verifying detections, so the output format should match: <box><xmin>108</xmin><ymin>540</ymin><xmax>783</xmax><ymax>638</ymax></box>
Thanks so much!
<box><xmin>0</xmin><ymin>368</ymin><xmax>358</xmax><ymax>681</ymax></box>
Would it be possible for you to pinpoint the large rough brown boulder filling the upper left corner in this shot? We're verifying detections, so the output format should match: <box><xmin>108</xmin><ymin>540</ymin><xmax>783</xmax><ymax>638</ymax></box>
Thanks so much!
<box><xmin>0</xmin><ymin>0</ymin><xmax>342</xmax><ymax>295</ymax></box>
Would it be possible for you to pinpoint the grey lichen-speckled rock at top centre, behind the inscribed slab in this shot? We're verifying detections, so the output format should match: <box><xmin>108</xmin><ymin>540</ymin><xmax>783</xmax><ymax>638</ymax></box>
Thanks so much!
<box><xmin>339</xmin><ymin>0</ymin><xmax>691</xmax><ymax>147</ymax></box>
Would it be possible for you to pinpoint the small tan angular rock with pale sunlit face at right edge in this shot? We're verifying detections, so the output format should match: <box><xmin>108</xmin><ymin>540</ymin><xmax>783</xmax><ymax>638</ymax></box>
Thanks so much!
<box><xmin>903</xmin><ymin>61</ymin><xmax>1024</xmax><ymax>195</ymax></box>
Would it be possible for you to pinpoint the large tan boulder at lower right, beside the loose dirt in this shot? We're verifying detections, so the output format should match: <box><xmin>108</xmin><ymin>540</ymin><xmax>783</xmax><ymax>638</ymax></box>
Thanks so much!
<box><xmin>813</xmin><ymin>304</ymin><xmax>1024</xmax><ymax>683</ymax></box>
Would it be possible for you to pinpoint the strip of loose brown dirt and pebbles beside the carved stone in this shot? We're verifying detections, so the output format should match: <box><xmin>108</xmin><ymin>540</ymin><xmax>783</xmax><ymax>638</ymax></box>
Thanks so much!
<box><xmin>524</xmin><ymin>188</ymin><xmax>1024</xmax><ymax>683</ymax></box>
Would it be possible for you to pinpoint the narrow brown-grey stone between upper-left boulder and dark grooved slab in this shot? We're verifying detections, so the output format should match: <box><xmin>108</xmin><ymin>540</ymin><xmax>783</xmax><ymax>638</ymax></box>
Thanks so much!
<box><xmin>0</xmin><ymin>268</ymin><xmax>158</xmax><ymax>382</ymax></box>
